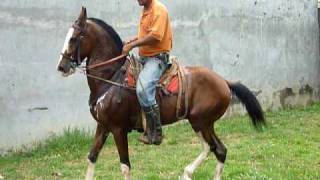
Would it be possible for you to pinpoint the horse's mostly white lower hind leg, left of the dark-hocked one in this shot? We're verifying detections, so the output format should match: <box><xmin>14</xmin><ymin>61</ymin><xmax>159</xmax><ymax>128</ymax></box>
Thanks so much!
<box><xmin>181</xmin><ymin>132</ymin><xmax>210</xmax><ymax>180</ymax></box>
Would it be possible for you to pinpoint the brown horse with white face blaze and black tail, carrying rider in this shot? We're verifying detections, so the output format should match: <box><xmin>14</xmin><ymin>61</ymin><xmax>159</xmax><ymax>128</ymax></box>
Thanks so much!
<box><xmin>57</xmin><ymin>8</ymin><xmax>265</xmax><ymax>179</ymax></box>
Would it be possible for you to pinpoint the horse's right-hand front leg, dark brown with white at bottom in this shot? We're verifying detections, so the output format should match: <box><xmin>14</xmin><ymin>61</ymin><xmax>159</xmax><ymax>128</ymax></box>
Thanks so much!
<box><xmin>112</xmin><ymin>128</ymin><xmax>131</xmax><ymax>180</ymax></box>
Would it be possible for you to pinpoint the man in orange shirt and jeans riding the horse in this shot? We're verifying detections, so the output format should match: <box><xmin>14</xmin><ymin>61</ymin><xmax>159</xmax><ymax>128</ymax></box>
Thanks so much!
<box><xmin>123</xmin><ymin>0</ymin><xmax>172</xmax><ymax>145</ymax></box>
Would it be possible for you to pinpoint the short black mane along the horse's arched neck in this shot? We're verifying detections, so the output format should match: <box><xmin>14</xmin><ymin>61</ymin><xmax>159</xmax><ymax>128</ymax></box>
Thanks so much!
<box><xmin>88</xmin><ymin>17</ymin><xmax>123</xmax><ymax>52</ymax></box>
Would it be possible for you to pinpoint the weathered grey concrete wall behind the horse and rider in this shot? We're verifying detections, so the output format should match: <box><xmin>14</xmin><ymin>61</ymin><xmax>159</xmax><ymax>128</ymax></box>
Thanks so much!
<box><xmin>0</xmin><ymin>0</ymin><xmax>320</xmax><ymax>152</ymax></box>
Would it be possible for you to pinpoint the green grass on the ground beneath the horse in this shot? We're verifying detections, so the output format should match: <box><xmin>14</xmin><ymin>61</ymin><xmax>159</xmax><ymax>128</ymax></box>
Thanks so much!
<box><xmin>0</xmin><ymin>104</ymin><xmax>320</xmax><ymax>180</ymax></box>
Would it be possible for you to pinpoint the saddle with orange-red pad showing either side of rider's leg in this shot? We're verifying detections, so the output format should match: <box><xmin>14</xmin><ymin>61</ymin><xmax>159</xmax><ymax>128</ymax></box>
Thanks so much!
<box><xmin>125</xmin><ymin>56</ymin><xmax>182</xmax><ymax>96</ymax></box>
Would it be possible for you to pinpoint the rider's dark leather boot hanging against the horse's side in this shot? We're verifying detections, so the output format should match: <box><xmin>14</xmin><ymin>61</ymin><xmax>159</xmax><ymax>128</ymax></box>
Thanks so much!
<box><xmin>139</xmin><ymin>105</ymin><xmax>162</xmax><ymax>145</ymax></box>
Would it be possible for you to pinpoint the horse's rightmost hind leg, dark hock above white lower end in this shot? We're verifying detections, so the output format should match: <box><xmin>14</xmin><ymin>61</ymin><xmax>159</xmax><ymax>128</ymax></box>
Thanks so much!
<box><xmin>202</xmin><ymin>128</ymin><xmax>227</xmax><ymax>180</ymax></box>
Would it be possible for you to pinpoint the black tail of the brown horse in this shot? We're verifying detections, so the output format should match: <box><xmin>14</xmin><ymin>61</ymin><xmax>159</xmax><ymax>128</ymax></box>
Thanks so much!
<box><xmin>228</xmin><ymin>83</ymin><xmax>266</xmax><ymax>130</ymax></box>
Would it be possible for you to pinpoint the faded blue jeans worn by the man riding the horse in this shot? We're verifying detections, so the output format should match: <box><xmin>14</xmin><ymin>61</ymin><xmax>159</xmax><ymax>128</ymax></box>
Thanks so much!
<box><xmin>136</xmin><ymin>57</ymin><xmax>167</xmax><ymax>107</ymax></box>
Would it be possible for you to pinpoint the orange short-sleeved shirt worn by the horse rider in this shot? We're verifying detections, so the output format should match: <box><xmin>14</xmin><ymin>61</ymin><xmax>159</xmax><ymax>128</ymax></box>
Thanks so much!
<box><xmin>138</xmin><ymin>0</ymin><xmax>172</xmax><ymax>57</ymax></box>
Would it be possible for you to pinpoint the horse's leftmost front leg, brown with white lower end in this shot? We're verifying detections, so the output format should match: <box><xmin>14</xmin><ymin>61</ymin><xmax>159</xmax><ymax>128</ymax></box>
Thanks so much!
<box><xmin>86</xmin><ymin>124</ymin><xmax>109</xmax><ymax>180</ymax></box>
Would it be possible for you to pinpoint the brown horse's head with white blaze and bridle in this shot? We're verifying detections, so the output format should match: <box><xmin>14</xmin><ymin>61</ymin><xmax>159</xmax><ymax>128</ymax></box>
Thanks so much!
<box><xmin>57</xmin><ymin>7</ymin><xmax>90</xmax><ymax>76</ymax></box>
